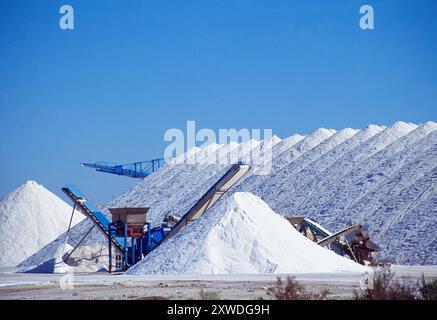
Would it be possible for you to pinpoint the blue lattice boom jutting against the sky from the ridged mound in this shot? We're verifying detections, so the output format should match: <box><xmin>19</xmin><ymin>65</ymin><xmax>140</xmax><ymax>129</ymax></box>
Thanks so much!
<box><xmin>80</xmin><ymin>159</ymin><xmax>165</xmax><ymax>179</ymax></box>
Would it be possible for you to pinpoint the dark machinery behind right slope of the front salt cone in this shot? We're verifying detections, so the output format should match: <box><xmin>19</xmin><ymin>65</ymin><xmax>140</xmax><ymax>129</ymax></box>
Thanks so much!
<box><xmin>287</xmin><ymin>217</ymin><xmax>379</xmax><ymax>265</ymax></box>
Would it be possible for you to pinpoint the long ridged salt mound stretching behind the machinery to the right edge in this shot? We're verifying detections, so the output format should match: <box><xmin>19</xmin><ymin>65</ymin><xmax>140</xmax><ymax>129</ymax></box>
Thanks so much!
<box><xmin>22</xmin><ymin>122</ymin><xmax>437</xmax><ymax>270</ymax></box>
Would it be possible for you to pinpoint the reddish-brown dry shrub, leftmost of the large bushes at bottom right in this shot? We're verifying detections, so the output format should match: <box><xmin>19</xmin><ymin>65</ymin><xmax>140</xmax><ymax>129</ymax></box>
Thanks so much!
<box><xmin>267</xmin><ymin>276</ymin><xmax>329</xmax><ymax>300</ymax></box>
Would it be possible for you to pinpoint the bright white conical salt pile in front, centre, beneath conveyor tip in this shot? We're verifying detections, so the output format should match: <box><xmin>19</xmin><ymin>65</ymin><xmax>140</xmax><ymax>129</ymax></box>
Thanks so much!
<box><xmin>128</xmin><ymin>192</ymin><xmax>364</xmax><ymax>274</ymax></box>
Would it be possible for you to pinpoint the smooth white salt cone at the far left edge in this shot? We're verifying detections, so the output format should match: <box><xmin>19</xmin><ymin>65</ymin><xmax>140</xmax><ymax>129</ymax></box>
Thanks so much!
<box><xmin>0</xmin><ymin>181</ymin><xmax>83</xmax><ymax>267</ymax></box>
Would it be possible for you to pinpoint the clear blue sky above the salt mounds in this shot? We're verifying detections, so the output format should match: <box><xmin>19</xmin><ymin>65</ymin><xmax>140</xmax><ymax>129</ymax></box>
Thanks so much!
<box><xmin>0</xmin><ymin>0</ymin><xmax>437</xmax><ymax>203</ymax></box>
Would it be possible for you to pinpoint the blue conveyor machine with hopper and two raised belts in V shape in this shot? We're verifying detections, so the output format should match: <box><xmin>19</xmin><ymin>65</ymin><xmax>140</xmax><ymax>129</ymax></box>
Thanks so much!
<box><xmin>62</xmin><ymin>163</ymin><xmax>250</xmax><ymax>272</ymax></box>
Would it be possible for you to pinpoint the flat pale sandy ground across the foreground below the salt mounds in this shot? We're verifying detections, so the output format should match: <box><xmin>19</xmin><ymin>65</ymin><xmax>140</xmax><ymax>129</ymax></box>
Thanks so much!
<box><xmin>0</xmin><ymin>266</ymin><xmax>437</xmax><ymax>300</ymax></box>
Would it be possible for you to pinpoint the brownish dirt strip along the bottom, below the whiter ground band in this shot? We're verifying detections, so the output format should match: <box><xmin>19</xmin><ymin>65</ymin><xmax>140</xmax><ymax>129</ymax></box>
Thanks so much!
<box><xmin>0</xmin><ymin>280</ymin><xmax>358</xmax><ymax>300</ymax></box>
